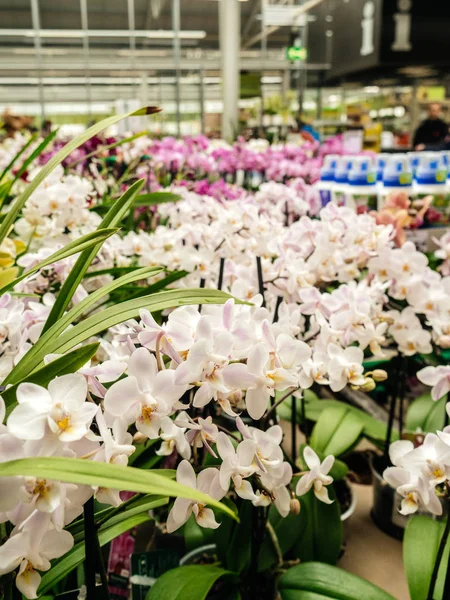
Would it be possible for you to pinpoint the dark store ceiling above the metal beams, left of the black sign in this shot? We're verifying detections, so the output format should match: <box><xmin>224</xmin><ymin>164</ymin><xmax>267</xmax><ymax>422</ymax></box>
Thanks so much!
<box><xmin>0</xmin><ymin>0</ymin><xmax>289</xmax><ymax>49</ymax></box>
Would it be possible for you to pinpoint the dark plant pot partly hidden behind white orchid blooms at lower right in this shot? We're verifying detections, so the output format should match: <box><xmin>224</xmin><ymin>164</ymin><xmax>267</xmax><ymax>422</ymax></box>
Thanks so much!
<box><xmin>370</xmin><ymin>455</ymin><xmax>447</xmax><ymax>540</ymax></box>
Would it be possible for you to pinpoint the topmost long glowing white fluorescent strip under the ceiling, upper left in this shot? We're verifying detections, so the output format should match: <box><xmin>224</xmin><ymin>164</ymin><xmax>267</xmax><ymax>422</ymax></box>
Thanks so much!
<box><xmin>0</xmin><ymin>29</ymin><xmax>206</xmax><ymax>40</ymax></box>
